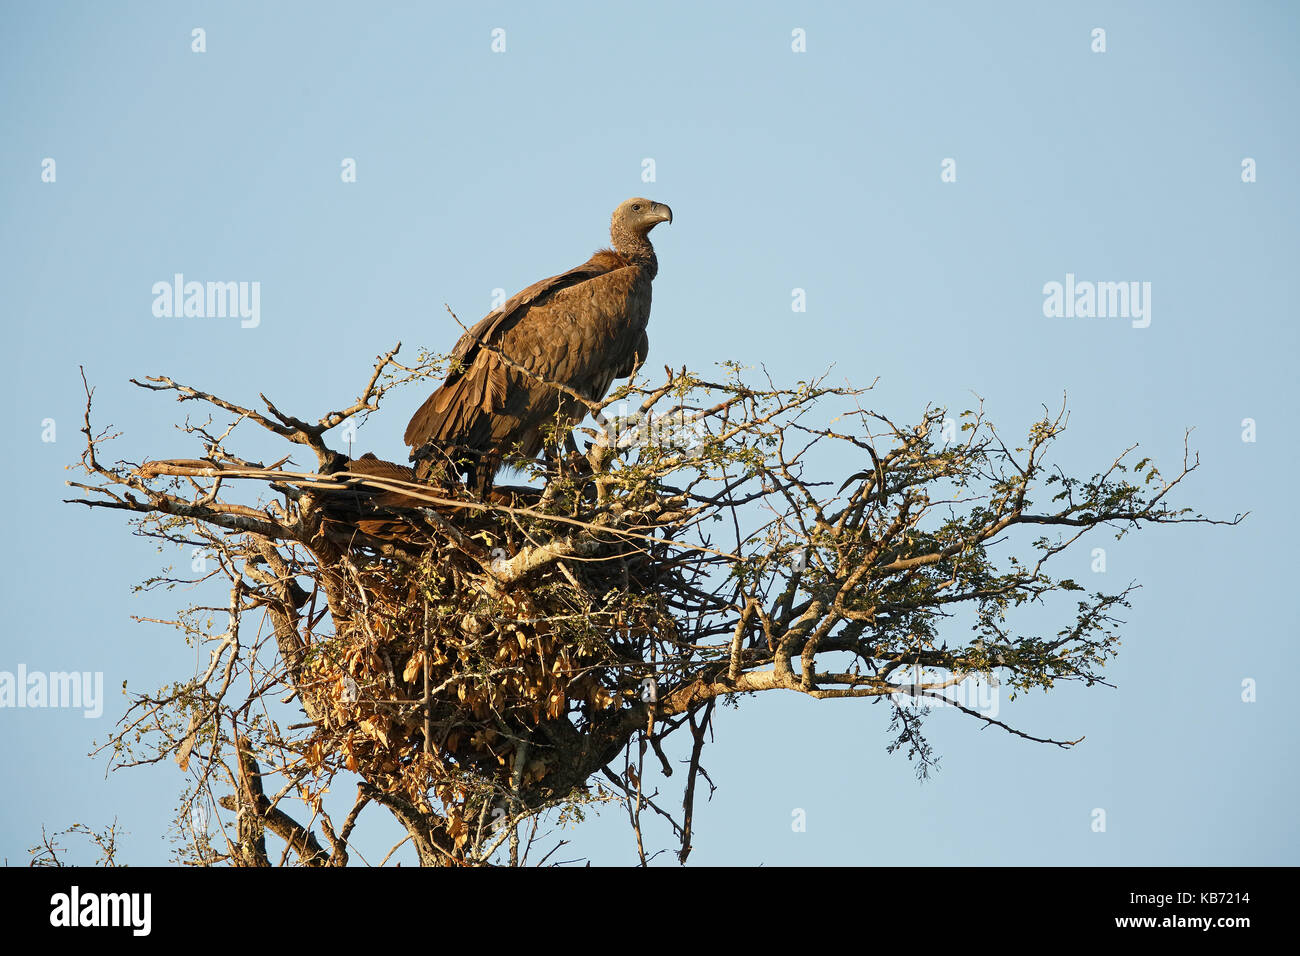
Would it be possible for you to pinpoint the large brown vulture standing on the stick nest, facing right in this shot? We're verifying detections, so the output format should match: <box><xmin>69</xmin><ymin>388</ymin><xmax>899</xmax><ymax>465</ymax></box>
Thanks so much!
<box><xmin>406</xmin><ymin>198</ymin><xmax>672</xmax><ymax>494</ymax></box>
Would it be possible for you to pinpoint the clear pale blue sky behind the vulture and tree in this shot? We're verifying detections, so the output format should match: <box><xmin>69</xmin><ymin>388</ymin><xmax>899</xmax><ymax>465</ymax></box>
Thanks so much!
<box><xmin>0</xmin><ymin>0</ymin><xmax>1300</xmax><ymax>865</ymax></box>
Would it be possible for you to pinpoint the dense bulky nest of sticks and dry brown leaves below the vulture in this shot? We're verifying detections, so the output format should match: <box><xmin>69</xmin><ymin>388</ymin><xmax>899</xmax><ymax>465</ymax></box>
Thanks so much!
<box><xmin>289</xmin><ymin>481</ymin><xmax>681</xmax><ymax>852</ymax></box>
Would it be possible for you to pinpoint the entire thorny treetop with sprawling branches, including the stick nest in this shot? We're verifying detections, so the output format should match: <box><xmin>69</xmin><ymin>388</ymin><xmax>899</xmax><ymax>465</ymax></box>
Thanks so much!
<box><xmin>63</xmin><ymin>349</ymin><xmax>1239</xmax><ymax>865</ymax></box>
